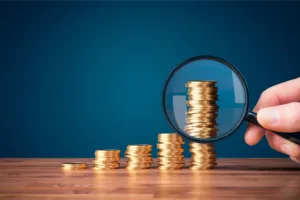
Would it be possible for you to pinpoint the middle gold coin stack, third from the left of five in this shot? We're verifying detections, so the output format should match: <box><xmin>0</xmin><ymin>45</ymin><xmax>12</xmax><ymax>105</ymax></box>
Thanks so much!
<box><xmin>125</xmin><ymin>144</ymin><xmax>152</xmax><ymax>169</ymax></box>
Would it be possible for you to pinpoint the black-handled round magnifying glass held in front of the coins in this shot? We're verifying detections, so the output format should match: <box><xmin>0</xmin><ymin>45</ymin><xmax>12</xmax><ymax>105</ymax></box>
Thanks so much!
<box><xmin>162</xmin><ymin>56</ymin><xmax>300</xmax><ymax>145</ymax></box>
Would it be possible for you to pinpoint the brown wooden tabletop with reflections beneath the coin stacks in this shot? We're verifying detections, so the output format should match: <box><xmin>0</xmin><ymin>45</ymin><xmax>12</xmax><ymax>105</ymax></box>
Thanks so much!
<box><xmin>0</xmin><ymin>159</ymin><xmax>300</xmax><ymax>200</ymax></box>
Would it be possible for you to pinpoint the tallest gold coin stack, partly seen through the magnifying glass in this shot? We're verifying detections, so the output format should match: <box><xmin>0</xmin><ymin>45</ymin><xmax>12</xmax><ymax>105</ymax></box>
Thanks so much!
<box><xmin>185</xmin><ymin>81</ymin><xmax>219</xmax><ymax>169</ymax></box>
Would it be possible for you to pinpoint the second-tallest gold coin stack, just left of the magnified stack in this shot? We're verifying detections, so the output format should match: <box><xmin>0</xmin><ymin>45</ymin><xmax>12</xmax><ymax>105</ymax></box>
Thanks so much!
<box><xmin>157</xmin><ymin>133</ymin><xmax>184</xmax><ymax>170</ymax></box>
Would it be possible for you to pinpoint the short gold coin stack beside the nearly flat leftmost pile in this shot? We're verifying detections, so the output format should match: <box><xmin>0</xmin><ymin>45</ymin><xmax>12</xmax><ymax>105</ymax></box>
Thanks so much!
<box><xmin>94</xmin><ymin>149</ymin><xmax>120</xmax><ymax>169</ymax></box>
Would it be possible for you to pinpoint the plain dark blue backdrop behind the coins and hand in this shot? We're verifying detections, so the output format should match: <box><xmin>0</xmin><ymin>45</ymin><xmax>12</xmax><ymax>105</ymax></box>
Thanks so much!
<box><xmin>0</xmin><ymin>0</ymin><xmax>300</xmax><ymax>157</ymax></box>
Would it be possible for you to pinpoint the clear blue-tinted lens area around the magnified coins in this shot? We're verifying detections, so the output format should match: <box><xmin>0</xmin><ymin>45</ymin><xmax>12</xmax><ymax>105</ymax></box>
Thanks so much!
<box><xmin>164</xmin><ymin>59</ymin><xmax>247</xmax><ymax>141</ymax></box>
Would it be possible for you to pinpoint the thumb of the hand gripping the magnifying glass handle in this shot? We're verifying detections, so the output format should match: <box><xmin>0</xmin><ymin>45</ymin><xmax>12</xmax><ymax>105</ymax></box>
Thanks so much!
<box><xmin>257</xmin><ymin>102</ymin><xmax>300</xmax><ymax>133</ymax></box>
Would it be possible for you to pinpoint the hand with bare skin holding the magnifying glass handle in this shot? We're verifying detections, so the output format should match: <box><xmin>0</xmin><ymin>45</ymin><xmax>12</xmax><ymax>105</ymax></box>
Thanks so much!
<box><xmin>245</xmin><ymin>77</ymin><xmax>300</xmax><ymax>164</ymax></box>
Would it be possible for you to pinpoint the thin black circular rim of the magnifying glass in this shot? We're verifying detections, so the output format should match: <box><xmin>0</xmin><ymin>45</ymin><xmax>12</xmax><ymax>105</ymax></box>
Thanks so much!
<box><xmin>162</xmin><ymin>55</ymin><xmax>249</xmax><ymax>143</ymax></box>
